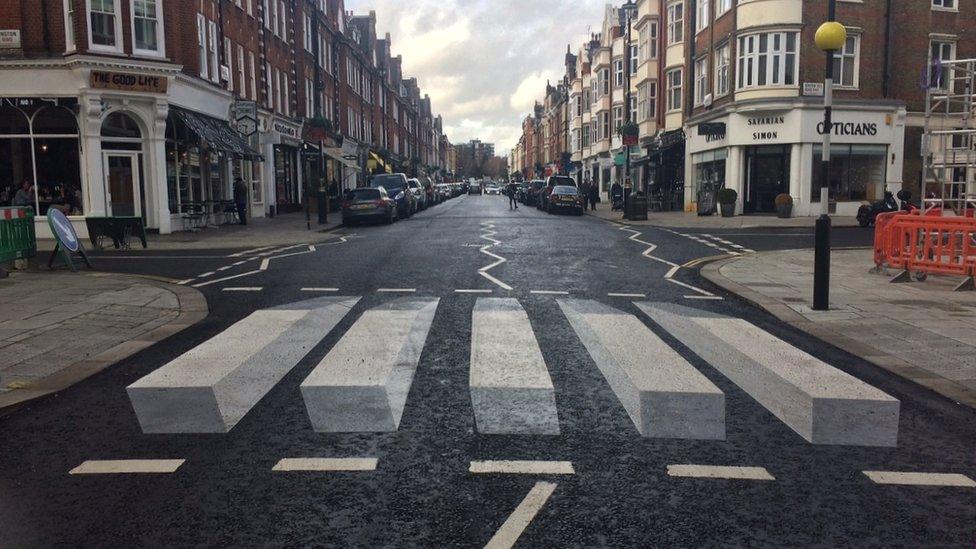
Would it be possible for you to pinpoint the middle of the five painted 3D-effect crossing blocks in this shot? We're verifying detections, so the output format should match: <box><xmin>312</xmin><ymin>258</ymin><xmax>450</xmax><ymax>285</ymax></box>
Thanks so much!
<box><xmin>469</xmin><ymin>298</ymin><xmax>559</xmax><ymax>435</ymax></box>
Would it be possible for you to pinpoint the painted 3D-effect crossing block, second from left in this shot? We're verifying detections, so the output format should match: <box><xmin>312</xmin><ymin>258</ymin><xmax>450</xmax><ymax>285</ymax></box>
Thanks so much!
<box><xmin>301</xmin><ymin>297</ymin><xmax>440</xmax><ymax>433</ymax></box>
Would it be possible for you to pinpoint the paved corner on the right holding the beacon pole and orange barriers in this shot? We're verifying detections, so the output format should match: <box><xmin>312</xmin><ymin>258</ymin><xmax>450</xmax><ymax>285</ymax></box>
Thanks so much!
<box><xmin>702</xmin><ymin>249</ymin><xmax>976</xmax><ymax>407</ymax></box>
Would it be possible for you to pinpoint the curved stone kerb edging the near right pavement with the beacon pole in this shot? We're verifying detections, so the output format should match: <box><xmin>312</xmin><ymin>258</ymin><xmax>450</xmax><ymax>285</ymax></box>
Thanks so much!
<box><xmin>701</xmin><ymin>253</ymin><xmax>976</xmax><ymax>408</ymax></box>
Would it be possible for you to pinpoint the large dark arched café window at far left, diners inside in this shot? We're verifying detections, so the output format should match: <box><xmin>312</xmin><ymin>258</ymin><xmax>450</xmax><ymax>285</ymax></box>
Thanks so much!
<box><xmin>0</xmin><ymin>105</ymin><xmax>84</xmax><ymax>215</ymax></box>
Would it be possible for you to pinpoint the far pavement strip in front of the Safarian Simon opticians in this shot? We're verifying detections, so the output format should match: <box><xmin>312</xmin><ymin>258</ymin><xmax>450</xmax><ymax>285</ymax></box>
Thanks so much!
<box><xmin>586</xmin><ymin>208</ymin><xmax>859</xmax><ymax>229</ymax></box>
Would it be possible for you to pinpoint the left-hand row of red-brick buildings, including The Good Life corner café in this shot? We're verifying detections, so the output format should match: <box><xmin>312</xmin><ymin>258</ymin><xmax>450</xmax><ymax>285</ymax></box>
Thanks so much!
<box><xmin>0</xmin><ymin>0</ymin><xmax>450</xmax><ymax>236</ymax></box>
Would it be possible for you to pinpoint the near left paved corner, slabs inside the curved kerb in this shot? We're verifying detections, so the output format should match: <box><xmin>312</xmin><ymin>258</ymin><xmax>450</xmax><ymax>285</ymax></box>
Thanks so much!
<box><xmin>0</xmin><ymin>271</ymin><xmax>208</xmax><ymax>413</ymax></box>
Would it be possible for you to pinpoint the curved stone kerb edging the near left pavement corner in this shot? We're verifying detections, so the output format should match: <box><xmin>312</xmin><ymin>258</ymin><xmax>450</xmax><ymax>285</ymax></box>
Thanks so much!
<box><xmin>0</xmin><ymin>273</ymin><xmax>210</xmax><ymax>416</ymax></box>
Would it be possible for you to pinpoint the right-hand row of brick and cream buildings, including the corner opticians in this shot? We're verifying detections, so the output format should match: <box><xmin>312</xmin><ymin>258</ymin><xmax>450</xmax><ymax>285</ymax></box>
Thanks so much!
<box><xmin>513</xmin><ymin>0</ymin><xmax>976</xmax><ymax>215</ymax></box>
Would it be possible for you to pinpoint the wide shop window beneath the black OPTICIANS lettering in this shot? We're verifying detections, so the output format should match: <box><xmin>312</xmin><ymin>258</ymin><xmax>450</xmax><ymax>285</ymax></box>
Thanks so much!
<box><xmin>810</xmin><ymin>145</ymin><xmax>888</xmax><ymax>202</ymax></box>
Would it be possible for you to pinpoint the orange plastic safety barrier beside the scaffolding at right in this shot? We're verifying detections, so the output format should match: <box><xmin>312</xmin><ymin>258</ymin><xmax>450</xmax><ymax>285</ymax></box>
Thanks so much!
<box><xmin>874</xmin><ymin>212</ymin><xmax>976</xmax><ymax>277</ymax></box>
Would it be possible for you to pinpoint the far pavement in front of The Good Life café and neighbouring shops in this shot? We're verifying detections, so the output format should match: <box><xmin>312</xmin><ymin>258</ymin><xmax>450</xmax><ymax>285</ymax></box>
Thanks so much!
<box><xmin>37</xmin><ymin>212</ymin><xmax>342</xmax><ymax>251</ymax></box>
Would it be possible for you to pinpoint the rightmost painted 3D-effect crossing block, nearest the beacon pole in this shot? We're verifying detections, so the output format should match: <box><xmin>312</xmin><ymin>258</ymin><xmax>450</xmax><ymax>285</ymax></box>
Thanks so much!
<box><xmin>635</xmin><ymin>303</ymin><xmax>900</xmax><ymax>446</ymax></box>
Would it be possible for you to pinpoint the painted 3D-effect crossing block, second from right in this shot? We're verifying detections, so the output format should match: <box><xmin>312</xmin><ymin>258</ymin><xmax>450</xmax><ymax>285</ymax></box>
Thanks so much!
<box><xmin>557</xmin><ymin>299</ymin><xmax>725</xmax><ymax>440</ymax></box>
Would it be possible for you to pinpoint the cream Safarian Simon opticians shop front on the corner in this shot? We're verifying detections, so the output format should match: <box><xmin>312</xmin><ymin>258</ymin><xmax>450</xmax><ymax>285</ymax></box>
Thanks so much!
<box><xmin>685</xmin><ymin>102</ymin><xmax>905</xmax><ymax>216</ymax></box>
